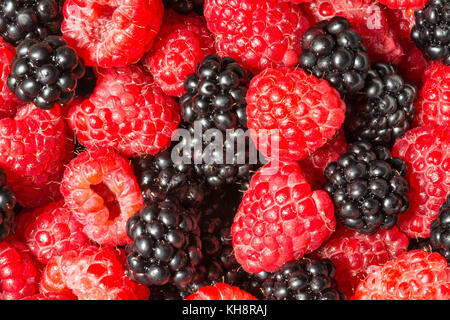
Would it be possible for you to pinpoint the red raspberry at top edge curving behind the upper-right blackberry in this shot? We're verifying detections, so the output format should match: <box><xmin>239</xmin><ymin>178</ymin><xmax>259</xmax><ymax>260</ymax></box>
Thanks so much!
<box><xmin>302</xmin><ymin>0</ymin><xmax>404</xmax><ymax>64</ymax></box>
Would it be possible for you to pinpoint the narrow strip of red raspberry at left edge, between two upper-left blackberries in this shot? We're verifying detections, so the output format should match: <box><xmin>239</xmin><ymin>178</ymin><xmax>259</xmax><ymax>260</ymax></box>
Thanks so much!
<box><xmin>0</xmin><ymin>38</ymin><xmax>23</xmax><ymax>119</ymax></box>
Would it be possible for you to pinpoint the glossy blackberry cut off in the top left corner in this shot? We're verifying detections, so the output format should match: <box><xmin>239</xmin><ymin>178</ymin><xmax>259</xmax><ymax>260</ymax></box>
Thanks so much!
<box><xmin>0</xmin><ymin>0</ymin><xmax>64</xmax><ymax>46</ymax></box>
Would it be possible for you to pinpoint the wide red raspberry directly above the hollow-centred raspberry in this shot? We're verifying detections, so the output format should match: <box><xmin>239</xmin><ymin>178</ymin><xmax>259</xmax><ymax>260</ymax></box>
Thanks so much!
<box><xmin>68</xmin><ymin>65</ymin><xmax>180</xmax><ymax>156</ymax></box>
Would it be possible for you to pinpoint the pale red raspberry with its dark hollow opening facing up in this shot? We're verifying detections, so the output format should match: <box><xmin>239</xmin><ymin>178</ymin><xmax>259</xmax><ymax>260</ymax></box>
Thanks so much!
<box><xmin>61</xmin><ymin>150</ymin><xmax>144</xmax><ymax>246</ymax></box>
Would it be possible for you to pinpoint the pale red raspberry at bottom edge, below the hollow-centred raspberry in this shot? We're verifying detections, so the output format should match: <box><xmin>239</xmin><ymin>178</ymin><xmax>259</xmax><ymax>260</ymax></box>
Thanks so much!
<box><xmin>40</xmin><ymin>246</ymin><xmax>150</xmax><ymax>300</ymax></box>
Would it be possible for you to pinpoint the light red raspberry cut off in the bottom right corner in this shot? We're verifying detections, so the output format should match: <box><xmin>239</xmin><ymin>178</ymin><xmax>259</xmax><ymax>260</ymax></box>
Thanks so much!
<box><xmin>352</xmin><ymin>250</ymin><xmax>450</xmax><ymax>300</ymax></box>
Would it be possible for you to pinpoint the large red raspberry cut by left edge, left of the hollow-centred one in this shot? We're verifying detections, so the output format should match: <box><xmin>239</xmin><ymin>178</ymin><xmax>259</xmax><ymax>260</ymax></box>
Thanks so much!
<box><xmin>0</xmin><ymin>104</ymin><xmax>73</xmax><ymax>208</ymax></box>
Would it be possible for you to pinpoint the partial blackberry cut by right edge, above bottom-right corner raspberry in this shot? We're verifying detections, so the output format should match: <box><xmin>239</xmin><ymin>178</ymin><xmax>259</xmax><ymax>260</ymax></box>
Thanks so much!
<box><xmin>430</xmin><ymin>195</ymin><xmax>450</xmax><ymax>263</ymax></box>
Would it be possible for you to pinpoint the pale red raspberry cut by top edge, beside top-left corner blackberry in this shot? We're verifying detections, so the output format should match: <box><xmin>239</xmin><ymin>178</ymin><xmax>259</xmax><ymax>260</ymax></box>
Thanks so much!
<box><xmin>61</xmin><ymin>0</ymin><xmax>164</xmax><ymax>68</ymax></box>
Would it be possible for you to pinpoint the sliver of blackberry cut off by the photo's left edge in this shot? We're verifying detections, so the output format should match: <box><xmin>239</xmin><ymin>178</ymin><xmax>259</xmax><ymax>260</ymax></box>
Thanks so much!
<box><xmin>0</xmin><ymin>168</ymin><xmax>16</xmax><ymax>242</ymax></box>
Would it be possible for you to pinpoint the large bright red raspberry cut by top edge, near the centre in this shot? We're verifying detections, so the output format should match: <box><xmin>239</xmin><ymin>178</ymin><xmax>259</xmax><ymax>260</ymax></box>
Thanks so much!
<box><xmin>204</xmin><ymin>0</ymin><xmax>310</xmax><ymax>74</ymax></box>
